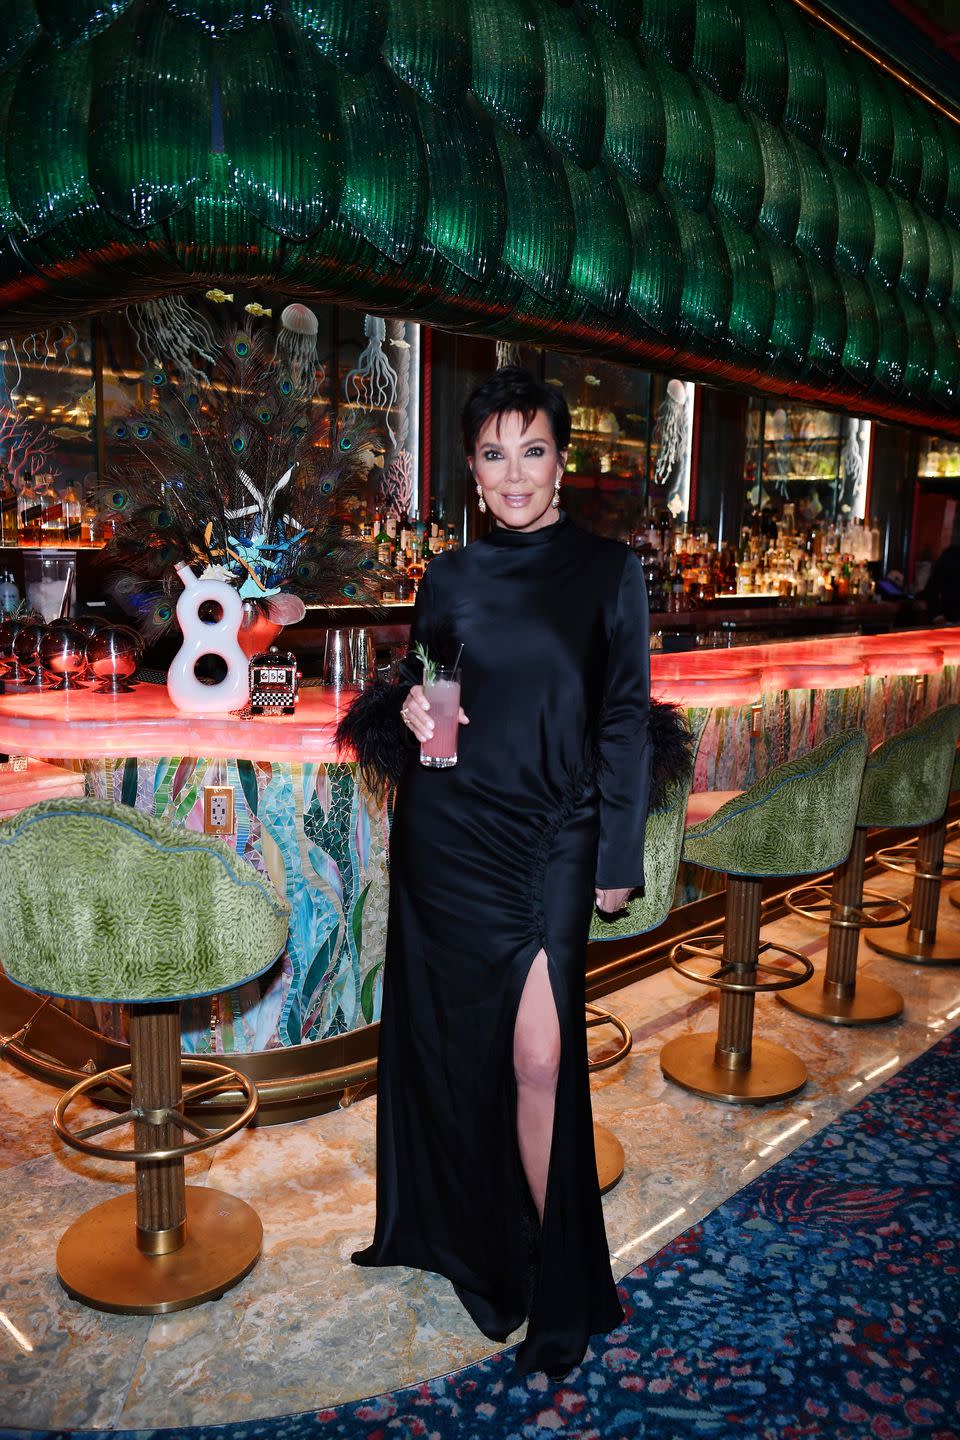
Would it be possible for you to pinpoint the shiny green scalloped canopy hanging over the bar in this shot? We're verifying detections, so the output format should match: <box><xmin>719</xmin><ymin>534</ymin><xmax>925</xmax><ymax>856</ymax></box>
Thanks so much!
<box><xmin>0</xmin><ymin>0</ymin><xmax>960</xmax><ymax>433</ymax></box>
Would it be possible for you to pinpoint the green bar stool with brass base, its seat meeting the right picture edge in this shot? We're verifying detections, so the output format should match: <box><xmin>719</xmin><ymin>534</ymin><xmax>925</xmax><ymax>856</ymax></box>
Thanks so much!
<box><xmin>777</xmin><ymin>706</ymin><xmax>957</xmax><ymax>1025</ymax></box>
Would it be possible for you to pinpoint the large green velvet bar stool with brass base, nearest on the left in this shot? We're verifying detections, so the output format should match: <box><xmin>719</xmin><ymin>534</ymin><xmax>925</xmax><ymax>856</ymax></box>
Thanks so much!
<box><xmin>0</xmin><ymin>799</ymin><xmax>289</xmax><ymax>1315</ymax></box>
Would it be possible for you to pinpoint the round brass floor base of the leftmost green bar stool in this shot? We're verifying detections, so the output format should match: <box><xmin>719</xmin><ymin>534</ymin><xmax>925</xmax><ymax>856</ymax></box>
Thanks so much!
<box><xmin>56</xmin><ymin>1185</ymin><xmax>263</xmax><ymax>1315</ymax></box>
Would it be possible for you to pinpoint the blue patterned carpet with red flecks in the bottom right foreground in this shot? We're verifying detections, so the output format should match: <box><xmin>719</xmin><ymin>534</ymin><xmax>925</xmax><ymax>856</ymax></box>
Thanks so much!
<box><xmin>0</xmin><ymin>1032</ymin><xmax>960</xmax><ymax>1440</ymax></box>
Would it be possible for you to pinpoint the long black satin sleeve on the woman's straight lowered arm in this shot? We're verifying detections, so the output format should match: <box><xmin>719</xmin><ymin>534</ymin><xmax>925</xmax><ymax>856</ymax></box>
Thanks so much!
<box><xmin>596</xmin><ymin>553</ymin><xmax>651</xmax><ymax>890</ymax></box>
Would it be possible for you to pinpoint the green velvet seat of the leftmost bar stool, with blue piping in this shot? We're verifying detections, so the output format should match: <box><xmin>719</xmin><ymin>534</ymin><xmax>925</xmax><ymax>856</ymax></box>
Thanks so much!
<box><xmin>0</xmin><ymin>799</ymin><xmax>289</xmax><ymax>1002</ymax></box>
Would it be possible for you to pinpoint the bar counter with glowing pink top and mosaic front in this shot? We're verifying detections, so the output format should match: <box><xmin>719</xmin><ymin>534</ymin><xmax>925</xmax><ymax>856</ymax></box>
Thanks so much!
<box><xmin>0</xmin><ymin>628</ymin><xmax>960</xmax><ymax>1053</ymax></box>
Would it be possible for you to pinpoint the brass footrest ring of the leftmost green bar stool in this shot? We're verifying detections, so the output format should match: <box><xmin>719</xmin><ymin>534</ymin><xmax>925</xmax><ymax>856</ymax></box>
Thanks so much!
<box><xmin>53</xmin><ymin>1056</ymin><xmax>261</xmax><ymax>1161</ymax></box>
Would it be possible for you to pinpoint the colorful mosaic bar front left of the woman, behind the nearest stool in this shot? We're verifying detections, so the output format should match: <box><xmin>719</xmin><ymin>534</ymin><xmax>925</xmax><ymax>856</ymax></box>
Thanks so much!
<box><xmin>85</xmin><ymin>757</ymin><xmax>390</xmax><ymax>1053</ymax></box>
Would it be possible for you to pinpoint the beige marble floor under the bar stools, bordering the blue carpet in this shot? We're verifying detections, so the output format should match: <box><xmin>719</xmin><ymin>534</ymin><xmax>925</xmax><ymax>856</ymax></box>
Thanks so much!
<box><xmin>0</xmin><ymin>877</ymin><xmax>960</xmax><ymax>1430</ymax></box>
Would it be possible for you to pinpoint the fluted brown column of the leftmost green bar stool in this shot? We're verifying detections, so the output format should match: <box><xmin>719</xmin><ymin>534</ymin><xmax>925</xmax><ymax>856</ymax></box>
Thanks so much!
<box><xmin>130</xmin><ymin>1001</ymin><xmax>187</xmax><ymax>1254</ymax></box>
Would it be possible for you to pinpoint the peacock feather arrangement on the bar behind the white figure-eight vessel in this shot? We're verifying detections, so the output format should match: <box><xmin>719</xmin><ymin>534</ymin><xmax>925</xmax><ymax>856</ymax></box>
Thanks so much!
<box><xmin>107</xmin><ymin>328</ymin><xmax>383</xmax><ymax>639</ymax></box>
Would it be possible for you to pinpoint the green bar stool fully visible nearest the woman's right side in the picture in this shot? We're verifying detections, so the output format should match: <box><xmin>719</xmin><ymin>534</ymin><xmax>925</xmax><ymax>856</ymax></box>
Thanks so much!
<box><xmin>661</xmin><ymin>730</ymin><xmax>866</xmax><ymax>1104</ymax></box>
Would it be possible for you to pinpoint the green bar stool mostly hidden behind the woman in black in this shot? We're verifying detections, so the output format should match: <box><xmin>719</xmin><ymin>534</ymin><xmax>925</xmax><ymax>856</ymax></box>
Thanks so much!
<box><xmin>587</xmin><ymin>760</ymin><xmax>694</xmax><ymax>1194</ymax></box>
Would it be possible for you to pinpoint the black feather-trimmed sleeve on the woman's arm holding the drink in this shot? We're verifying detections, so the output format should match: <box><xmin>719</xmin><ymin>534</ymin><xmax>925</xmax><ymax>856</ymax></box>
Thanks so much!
<box><xmin>337</xmin><ymin>572</ymin><xmax>433</xmax><ymax>788</ymax></box>
